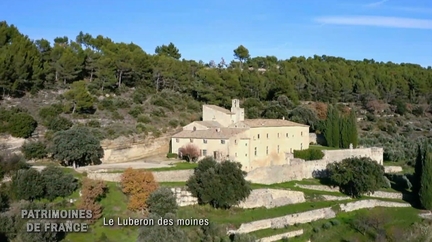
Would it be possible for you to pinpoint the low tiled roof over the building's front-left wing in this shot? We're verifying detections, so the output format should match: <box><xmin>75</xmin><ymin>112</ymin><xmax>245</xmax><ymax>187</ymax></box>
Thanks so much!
<box><xmin>172</xmin><ymin>128</ymin><xmax>248</xmax><ymax>139</ymax></box>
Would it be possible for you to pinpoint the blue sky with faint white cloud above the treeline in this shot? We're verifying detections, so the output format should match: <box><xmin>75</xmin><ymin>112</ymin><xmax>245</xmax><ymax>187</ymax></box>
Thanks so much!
<box><xmin>0</xmin><ymin>0</ymin><xmax>432</xmax><ymax>67</ymax></box>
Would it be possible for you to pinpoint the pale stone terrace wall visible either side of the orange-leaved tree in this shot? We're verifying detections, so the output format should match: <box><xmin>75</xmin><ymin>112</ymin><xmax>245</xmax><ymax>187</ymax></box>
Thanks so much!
<box><xmin>87</xmin><ymin>170</ymin><xmax>193</xmax><ymax>182</ymax></box>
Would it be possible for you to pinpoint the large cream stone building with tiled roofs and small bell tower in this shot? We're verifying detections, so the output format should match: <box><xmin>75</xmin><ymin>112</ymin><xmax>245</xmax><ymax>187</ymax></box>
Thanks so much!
<box><xmin>171</xmin><ymin>99</ymin><xmax>309</xmax><ymax>171</ymax></box>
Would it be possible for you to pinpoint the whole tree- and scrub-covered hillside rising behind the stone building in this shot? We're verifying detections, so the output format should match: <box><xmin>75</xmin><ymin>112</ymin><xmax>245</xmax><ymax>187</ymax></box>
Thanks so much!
<box><xmin>0</xmin><ymin>22</ymin><xmax>432</xmax><ymax>164</ymax></box>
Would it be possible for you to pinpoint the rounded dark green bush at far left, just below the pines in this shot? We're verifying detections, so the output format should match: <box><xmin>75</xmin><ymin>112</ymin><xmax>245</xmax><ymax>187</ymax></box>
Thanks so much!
<box><xmin>8</xmin><ymin>113</ymin><xmax>37</xmax><ymax>138</ymax></box>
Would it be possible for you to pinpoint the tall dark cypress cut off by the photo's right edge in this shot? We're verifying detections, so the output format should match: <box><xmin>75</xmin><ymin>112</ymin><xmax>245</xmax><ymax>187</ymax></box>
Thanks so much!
<box><xmin>419</xmin><ymin>144</ymin><xmax>432</xmax><ymax>210</ymax></box>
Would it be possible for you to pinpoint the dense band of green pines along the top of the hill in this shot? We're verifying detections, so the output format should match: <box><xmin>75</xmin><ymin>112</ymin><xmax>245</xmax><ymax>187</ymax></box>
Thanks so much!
<box><xmin>0</xmin><ymin>22</ymin><xmax>432</xmax><ymax>106</ymax></box>
